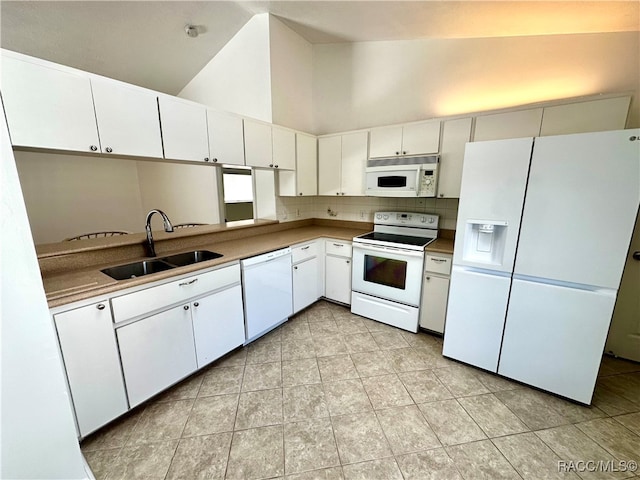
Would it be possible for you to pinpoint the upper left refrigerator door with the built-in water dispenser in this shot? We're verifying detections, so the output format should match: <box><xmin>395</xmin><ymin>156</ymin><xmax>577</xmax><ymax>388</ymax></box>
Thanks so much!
<box><xmin>453</xmin><ymin>138</ymin><xmax>533</xmax><ymax>273</ymax></box>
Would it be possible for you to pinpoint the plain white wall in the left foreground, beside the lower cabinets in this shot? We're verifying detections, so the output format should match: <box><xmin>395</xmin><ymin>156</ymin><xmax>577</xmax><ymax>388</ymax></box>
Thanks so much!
<box><xmin>0</xmin><ymin>100</ymin><xmax>88</xmax><ymax>480</ymax></box>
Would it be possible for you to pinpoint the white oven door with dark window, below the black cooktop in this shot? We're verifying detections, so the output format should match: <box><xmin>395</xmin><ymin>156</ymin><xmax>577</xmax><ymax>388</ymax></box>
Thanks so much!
<box><xmin>351</xmin><ymin>243</ymin><xmax>424</xmax><ymax>307</ymax></box>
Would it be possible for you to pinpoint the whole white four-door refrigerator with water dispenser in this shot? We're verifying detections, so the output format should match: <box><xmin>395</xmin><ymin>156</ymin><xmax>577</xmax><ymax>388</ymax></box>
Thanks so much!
<box><xmin>443</xmin><ymin>130</ymin><xmax>640</xmax><ymax>403</ymax></box>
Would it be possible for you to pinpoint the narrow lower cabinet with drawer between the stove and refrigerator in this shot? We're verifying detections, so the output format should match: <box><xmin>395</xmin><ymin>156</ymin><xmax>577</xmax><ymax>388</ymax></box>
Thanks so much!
<box><xmin>419</xmin><ymin>254</ymin><xmax>452</xmax><ymax>333</ymax></box>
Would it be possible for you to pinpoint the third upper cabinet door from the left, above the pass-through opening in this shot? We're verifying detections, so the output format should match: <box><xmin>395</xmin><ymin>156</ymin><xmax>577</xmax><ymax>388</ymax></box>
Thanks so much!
<box><xmin>158</xmin><ymin>97</ymin><xmax>209</xmax><ymax>162</ymax></box>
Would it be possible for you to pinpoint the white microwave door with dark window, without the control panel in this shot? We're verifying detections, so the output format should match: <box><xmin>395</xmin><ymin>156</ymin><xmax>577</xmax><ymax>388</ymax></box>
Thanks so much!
<box><xmin>365</xmin><ymin>166</ymin><xmax>421</xmax><ymax>197</ymax></box>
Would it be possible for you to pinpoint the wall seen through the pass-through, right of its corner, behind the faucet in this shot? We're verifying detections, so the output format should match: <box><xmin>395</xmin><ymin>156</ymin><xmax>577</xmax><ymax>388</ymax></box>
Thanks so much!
<box><xmin>137</xmin><ymin>162</ymin><xmax>220</xmax><ymax>231</ymax></box>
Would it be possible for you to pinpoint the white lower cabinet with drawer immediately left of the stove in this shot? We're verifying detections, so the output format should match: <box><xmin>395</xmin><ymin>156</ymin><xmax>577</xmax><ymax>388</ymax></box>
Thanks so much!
<box><xmin>324</xmin><ymin>240</ymin><xmax>351</xmax><ymax>305</ymax></box>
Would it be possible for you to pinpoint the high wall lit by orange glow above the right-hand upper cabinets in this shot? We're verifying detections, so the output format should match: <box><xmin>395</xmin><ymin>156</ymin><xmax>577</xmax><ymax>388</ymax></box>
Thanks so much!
<box><xmin>313</xmin><ymin>32</ymin><xmax>640</xmax><ymax>134</ymax></box>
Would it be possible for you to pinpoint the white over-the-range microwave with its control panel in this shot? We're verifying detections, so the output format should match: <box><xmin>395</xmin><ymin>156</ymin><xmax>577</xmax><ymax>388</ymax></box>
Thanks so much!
<box><xmin>365</xmin><ymin>155</ymin><xmax>439</xmax><ymax>197</ymax></box>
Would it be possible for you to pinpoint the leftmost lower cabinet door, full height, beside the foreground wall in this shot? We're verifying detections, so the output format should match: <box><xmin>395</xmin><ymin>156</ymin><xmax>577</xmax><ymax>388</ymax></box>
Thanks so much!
<box><xmin>54</xmin><ymin>301</ymin><xmax>128</xmax><ymax>436</ymax></box>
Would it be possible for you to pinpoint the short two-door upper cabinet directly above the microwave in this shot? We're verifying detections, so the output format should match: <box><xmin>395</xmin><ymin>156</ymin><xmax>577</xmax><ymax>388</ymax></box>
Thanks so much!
<box><xmin>369</xmin><ymin>120</ymin><xmax>440</xmax><ymax>158</ymax></box>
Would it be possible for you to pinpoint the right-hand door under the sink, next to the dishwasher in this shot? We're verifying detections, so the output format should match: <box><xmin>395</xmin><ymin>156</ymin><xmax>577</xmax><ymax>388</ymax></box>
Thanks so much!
<box><xmin>191</xmin><ymin>285</ymin><xmax>244</xmax><ymax>368</ymax></box>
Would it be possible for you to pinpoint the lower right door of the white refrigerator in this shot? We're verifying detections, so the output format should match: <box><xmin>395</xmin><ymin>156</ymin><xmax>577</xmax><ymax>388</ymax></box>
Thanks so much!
<box><xmin>498</xmin><ymin>278</ymin><xmax>616</xmax><ymax>404</ymax></box>
